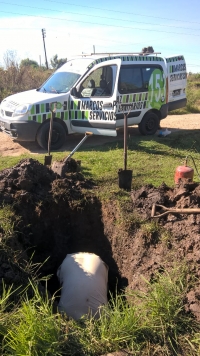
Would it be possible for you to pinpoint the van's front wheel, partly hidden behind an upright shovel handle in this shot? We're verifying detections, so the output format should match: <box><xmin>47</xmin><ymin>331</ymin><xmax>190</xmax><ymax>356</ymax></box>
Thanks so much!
<box><xmin>36</xmin><ymin>121</ymin><xmax>67</xmax><ymax>151</ymax></box>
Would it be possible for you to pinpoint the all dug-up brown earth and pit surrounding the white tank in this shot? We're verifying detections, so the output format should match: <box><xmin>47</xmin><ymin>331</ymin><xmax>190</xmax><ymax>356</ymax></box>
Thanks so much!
<box><xmin>0</xmin><ymin>158</ymin><xmax>200</xmax><ymax>320</ymax></box>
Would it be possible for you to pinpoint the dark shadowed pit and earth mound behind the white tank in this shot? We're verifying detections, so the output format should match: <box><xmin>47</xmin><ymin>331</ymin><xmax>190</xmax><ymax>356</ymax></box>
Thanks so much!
<box><xmin>0</xmin><ymin>159</ymin><xmax>124</xmax><ymax>294</ymax></box>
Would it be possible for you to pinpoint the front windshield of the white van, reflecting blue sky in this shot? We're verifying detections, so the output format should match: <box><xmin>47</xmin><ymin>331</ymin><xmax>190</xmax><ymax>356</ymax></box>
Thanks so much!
<box><xmin>38</xmin><ymin>72</ymin><xmax>80</xmax><ymax>94</ymax></box>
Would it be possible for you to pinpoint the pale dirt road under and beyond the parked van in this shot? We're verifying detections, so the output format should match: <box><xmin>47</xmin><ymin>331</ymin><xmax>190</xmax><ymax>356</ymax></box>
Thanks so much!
<box><xmin>0</xmin><ymin>114</ymin><xmax>200</xmax><ymax>157</ymax></box>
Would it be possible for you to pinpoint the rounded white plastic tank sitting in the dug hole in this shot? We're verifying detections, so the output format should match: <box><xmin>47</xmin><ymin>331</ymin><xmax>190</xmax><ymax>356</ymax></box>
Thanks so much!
<box><xmin>57</xmin><ymin>252</ymin><xmax>108</xmax><ymax>320</ymax></box>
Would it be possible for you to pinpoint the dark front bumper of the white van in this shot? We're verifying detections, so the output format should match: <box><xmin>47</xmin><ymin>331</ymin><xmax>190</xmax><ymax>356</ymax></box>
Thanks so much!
<box><xmin>0</xmin><ymin>117</ymin><xmax>41</xmax><ymax>141</ymax></box>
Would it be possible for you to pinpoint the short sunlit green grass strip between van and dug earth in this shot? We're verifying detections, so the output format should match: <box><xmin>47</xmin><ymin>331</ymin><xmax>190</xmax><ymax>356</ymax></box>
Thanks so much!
<box><xmin>0</xmin><ymin>130</ymin><xmax>200</xmax><ymax>191</ymax></box>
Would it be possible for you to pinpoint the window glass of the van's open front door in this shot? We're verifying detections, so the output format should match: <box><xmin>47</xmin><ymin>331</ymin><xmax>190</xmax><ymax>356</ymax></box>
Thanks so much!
<box><xmin>80</xmin><ymin>66</ymin><xmax>115</xmax><ymax>98</ymax></box>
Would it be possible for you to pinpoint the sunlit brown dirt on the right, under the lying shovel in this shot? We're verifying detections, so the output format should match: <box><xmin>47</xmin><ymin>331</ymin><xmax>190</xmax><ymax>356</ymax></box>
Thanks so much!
<box><xmin>119</xmin><ymin>181</ymin><xmax>200</xmax><ymax>320</ymax></box>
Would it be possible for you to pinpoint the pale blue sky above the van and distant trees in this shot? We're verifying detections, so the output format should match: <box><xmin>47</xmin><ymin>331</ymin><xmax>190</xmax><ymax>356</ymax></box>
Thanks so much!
<box><xmin>0</xmin><ymin>0</ymin><xmax>200</xmax><ymax>73</ymax></box>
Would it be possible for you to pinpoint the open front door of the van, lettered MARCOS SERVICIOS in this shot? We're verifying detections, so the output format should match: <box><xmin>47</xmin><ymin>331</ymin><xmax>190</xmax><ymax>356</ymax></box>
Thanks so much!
<box><xmin>69</xmin><ymin>58</ymin><xmax>121</xmax><ymax>136</ymax></box>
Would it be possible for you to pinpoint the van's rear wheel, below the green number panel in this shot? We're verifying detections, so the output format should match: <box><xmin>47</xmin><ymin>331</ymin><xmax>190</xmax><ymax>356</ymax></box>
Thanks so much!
<box><xmin>138</xmin><ymin>112</ymin><xmax>160</xmax><ymax>135</ymax></box>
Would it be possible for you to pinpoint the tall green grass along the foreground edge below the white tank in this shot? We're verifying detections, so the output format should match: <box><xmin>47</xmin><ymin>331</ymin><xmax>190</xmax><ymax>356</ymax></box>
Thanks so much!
<box><xmin>0</xmin><ymin>263</ymin><xmax>200</xmax><ymax>356</ymax></box>
